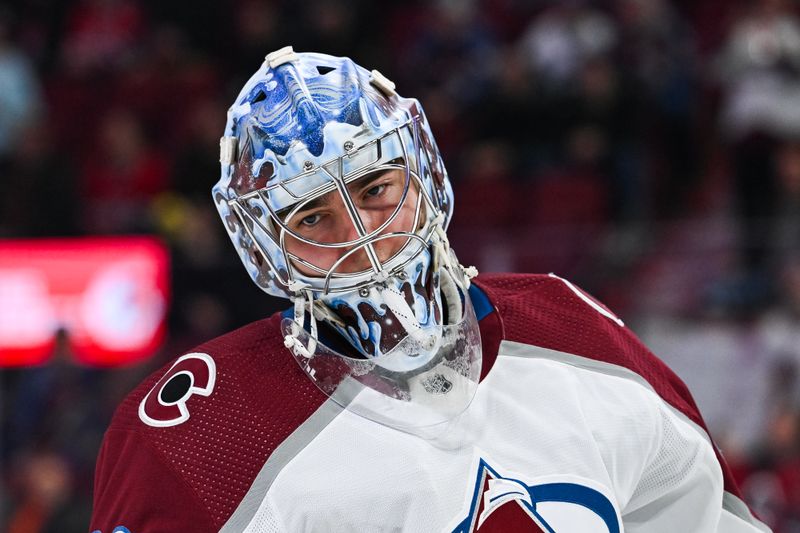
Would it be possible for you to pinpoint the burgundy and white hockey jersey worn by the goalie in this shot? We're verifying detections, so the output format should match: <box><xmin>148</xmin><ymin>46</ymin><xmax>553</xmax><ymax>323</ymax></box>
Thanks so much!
<box><xmin>91</xmin><ymin>275</ymin><xmax>769</xmax><ymax>533</ymax></box>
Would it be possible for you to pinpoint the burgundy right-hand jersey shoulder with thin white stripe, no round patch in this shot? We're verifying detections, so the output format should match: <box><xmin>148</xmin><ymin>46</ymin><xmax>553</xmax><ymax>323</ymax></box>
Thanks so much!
<box><xmin>472</xmin><ymin>274</ymin><xmax>741</xmax><ymax>499</ymax></box>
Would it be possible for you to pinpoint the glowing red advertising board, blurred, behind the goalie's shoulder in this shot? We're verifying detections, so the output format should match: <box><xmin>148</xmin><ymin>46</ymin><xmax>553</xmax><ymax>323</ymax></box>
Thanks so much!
<box><xmin>0</xmin><ymin>237</ymin><xmax>169</xmax><ymax>367</ymax></box>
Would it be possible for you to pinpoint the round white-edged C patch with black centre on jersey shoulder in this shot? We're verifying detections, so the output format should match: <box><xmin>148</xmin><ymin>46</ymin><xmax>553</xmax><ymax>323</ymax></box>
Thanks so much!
<box><xmin>139</xmin><ymin>353</ymin><xmax>217</xmax><ymax>427</ymax></box>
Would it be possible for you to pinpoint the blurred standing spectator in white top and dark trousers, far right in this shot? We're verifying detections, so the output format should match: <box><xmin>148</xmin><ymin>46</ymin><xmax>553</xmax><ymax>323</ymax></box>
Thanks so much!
<box><xmin>719</xmin><ymin>0</ymin><xmax>800</xmax><ymax>310</ymax></box>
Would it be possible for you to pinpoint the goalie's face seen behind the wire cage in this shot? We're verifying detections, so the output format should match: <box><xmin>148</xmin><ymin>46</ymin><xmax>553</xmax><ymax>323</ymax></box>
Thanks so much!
<box><xmin>283</xmin><ymin>166</ymin><xmax>423</xmax><ymax>276</ymax></box>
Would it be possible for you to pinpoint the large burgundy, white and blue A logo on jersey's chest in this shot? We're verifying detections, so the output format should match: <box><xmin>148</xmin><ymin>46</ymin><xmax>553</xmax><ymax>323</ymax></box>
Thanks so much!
<box><xmin>453</xmin><ymin>458</ymin><xmax>622</xmax><ymax>533</ymax></box>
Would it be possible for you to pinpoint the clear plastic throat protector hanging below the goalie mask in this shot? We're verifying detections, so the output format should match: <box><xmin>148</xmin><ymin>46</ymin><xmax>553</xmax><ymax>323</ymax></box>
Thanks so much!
<box><xmin>282</xmin><ymin>272</ymin><xmax>482</xmax><ymax>437</ymax></box>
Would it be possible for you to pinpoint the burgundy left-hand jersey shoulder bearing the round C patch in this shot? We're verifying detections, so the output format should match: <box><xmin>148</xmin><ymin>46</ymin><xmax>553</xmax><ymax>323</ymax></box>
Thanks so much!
<box><xmin>93</xmin><ymin>314</ymin><xmax>326</xmax><ymax>533</ymax></box>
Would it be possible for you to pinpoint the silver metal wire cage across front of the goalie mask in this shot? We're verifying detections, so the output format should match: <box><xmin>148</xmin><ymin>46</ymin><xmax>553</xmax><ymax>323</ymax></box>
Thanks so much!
<box><xmin>227</xmin><ymin>119</ymin><xmax>441</xmax><ymax>295</ymax></box>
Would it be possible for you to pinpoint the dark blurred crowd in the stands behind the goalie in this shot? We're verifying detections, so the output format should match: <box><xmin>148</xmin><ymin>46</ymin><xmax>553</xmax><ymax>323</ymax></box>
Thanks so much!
<box><xmin>0</xmin><ymin>0</ymin><xmax>800</xmax><ymax>533</ymax></box>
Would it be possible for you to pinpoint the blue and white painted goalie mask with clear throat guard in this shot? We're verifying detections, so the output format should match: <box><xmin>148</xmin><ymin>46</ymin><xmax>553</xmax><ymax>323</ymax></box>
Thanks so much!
<box><xmin>213</xmin><ymin>47</ymin><xmax>480</xmax><ymax>429</ymax></box>
